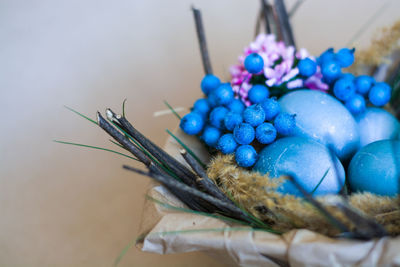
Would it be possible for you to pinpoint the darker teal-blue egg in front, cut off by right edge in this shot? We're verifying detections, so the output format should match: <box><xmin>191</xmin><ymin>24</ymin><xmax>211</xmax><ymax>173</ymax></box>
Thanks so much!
<box><xmin>348</xmin><ymin>140</ymin><xmax>400</xmax><ymax>196</ymax></box>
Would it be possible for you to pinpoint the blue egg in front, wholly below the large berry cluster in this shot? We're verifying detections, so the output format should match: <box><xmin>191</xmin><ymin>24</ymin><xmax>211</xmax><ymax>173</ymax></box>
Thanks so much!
<box><xmin>253</xmin><ymin>137</ymin><xmax>345</xmax><ymax>196</ymax></box>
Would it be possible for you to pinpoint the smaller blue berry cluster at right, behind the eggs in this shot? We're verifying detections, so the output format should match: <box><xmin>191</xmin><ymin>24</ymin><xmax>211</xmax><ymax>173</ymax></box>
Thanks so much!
<box><xmin>317</xmin><ymin>48</ymin><xmax>391</xmax><ymax>114</ymax></box>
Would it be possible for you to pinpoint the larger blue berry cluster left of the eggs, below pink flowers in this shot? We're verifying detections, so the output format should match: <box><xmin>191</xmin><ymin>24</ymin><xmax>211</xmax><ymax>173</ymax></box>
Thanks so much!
<box><xmin>180</xmin><ymin>54</ymin><xmax>295</xmax><ymax>167</ymax></box>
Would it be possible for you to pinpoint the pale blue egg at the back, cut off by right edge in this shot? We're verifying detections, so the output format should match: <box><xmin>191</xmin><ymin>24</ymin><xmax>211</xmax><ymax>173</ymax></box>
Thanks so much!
<box><xmin>356</xmin><ymin>107</ymin><xmax>400</xmax><ymax>148</ymax></box>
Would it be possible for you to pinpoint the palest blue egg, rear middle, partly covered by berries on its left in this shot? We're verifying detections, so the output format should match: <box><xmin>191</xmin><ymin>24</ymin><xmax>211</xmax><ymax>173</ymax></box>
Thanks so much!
<box><xmin>279</xmin><ymin>90</ymin><xmax>360</xmax><ymax>160</ymax></box>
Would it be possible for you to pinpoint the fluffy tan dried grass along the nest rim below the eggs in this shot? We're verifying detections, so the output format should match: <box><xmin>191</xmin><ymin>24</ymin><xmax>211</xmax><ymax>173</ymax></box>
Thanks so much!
<box><xmin>207</xmin><ymin>155</ymin><xmax>400</xmax><ymax>236</ymax></box>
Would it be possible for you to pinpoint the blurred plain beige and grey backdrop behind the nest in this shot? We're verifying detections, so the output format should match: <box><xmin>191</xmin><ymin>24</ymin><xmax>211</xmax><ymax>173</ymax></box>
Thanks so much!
<box><xmin>0</xmin><ymin>0</ymin><xmax>400</xmax><ymax>266</ymax></box>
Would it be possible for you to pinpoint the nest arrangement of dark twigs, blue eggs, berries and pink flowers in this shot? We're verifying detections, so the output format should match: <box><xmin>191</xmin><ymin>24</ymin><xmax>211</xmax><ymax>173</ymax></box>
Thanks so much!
<box><xmin>57</xmin><ymin>0</ymin><xmax>400</xmax><ymax>262</ymax></box>
